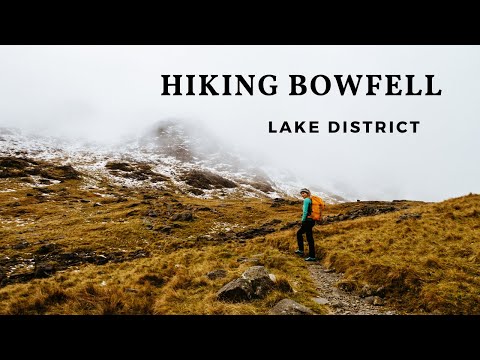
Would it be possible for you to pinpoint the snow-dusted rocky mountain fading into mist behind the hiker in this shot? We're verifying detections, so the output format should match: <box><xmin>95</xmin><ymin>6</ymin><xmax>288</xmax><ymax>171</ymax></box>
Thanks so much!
<box><xmin>0</xmin><ymin>119</ymin><xmax>345</xmax><ymax>203</ymax></box>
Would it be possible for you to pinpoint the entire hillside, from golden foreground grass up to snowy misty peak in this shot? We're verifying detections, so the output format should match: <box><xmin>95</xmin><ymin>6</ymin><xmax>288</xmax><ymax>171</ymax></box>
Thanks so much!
<box><xmin>0</xmin><ymin>120</ymin><xmax>480</xmax><ymax>314</ymax></box>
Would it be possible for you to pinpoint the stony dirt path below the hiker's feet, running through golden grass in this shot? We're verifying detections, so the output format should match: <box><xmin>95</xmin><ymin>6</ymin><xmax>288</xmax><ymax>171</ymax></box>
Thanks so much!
<box><xmin>308</xmin><ymin>263</ymin><xmax>397</xmax><ymax>315</ymax></box>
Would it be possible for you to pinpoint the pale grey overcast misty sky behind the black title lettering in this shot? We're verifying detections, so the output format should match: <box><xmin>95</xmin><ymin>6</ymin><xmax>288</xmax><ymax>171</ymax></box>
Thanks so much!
<box><xmin>0</xmin><ymin>46</ymin><xmax>480</xmax><ymax>201</ymax></box>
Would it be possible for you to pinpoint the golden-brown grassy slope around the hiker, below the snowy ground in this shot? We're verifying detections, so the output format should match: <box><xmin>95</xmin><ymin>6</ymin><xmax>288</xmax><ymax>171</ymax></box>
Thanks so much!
<box><xmin>0</xmin><ymin>175</ymin><xmax>480</xmax><ymax>314</ymax></box>
